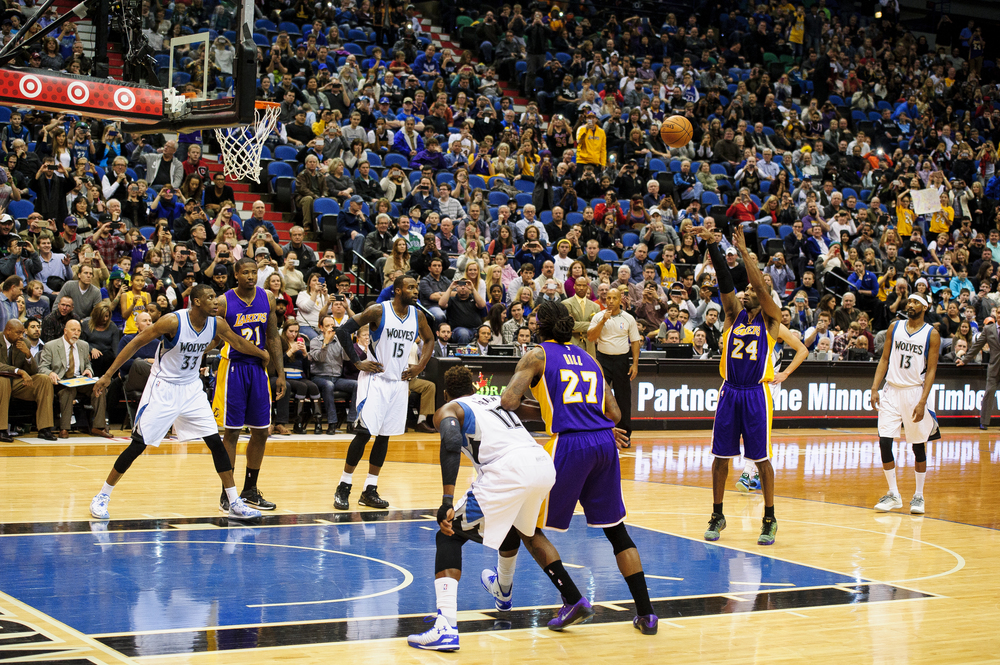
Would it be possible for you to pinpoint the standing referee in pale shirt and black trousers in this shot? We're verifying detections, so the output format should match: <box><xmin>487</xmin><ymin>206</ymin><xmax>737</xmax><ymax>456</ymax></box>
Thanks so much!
<box><xmin>587</xmin><ymin>289</ymin><xmax>642</xmax><ymax>448</ymax></box>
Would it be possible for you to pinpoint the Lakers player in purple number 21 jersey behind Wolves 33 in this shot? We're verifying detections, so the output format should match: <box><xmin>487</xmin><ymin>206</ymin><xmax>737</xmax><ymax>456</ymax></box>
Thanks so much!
<box><xmin>212</xmin><ymin>257</ymin><xmax>285</xmax><ymax>512</ymax></box>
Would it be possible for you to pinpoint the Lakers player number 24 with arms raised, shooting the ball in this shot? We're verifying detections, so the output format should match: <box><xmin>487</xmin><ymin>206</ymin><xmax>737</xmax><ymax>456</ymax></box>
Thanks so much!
<box><xmin>700</xmin><ymin>223</ymin><xmax>781</xmax><ymax>545</ymax></box>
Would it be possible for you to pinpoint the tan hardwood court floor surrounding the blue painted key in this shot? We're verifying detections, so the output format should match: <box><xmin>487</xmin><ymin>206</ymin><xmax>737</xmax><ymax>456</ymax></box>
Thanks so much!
<box><xmin>0</xmin><ymin>428</ymin><xmax>1000</xmax><ymax>665</ymax></box>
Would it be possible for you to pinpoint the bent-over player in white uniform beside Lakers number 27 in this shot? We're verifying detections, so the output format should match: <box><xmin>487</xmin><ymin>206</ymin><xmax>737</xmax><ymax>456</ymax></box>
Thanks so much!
<box><xmin>407</xmin><ymin>365</ymin><xmax>592</xmax><ymax>651</ymax></box>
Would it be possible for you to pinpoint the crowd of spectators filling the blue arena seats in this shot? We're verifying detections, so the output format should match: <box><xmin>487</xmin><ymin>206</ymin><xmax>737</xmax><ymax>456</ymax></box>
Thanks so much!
<box><xmin>0</xmin><ymin>0</ymin><xmax>1000</xmax><ymax>436</ymax></box>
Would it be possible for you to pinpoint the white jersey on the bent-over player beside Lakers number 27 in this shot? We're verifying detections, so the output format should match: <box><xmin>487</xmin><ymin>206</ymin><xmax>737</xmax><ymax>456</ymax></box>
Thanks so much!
<box><xmin>455</xmin><ymin>395</ymin><xmax>538</xmax><ymax>474</ymax></box>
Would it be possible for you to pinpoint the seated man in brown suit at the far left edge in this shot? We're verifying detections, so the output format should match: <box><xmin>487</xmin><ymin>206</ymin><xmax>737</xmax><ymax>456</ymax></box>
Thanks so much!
<box><xmin>0</xmin><ymin>319</ymin><xmax>56</xmax><ymax>443</ymax></box>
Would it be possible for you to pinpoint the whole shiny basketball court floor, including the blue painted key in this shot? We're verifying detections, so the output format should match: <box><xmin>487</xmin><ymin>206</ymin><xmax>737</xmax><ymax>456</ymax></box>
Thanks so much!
<box><xmin>0</xmin><ymin>429</ymin><xmax>1000</xmax><ymax>663</ymax></box>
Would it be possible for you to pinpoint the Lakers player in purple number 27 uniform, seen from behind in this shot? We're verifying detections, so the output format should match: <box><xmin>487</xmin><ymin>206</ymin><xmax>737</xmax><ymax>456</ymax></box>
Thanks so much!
<box><xmin>498</xmin><ymin>301</ymin><xmax>657</xmax><ymax>635</ymax></box>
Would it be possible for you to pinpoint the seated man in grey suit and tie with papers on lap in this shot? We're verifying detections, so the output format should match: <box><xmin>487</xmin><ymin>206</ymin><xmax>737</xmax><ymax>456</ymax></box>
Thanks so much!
<box><xmin>38</xmin><ymin>319</ymin><xmax>111</xmax><ymax>439</ymax></box>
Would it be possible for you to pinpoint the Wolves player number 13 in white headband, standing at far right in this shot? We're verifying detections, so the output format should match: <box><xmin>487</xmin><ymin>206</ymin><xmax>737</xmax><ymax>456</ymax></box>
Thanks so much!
<box><xmin>872</xmin><ymin>293</ymin><xmax>941</xmax><ymax>515</ymax></box>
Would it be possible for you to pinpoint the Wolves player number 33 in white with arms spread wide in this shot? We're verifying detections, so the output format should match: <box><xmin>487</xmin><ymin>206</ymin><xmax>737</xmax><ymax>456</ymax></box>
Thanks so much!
<box><xmin>90</xmin><ymin>284</ymin><xmax>270</xmax><ymax>522</ymax></box>
